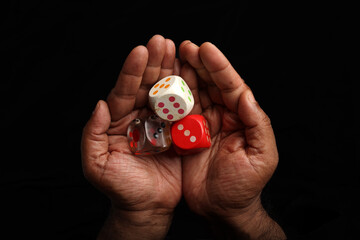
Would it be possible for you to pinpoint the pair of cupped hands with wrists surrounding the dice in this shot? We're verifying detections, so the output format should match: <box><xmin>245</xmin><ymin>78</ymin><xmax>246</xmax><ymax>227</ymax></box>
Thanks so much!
<box><xmin>82</xmin><ymin>35</ymin><xmax>286</xmax><ymax>239</ymax></box>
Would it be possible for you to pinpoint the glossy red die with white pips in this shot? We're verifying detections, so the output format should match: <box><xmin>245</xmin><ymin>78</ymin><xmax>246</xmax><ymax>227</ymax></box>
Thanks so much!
<box><xmin>171</xmin><ymin>115</ymin><xmax>211</xmax><ymax>149</ymax></box>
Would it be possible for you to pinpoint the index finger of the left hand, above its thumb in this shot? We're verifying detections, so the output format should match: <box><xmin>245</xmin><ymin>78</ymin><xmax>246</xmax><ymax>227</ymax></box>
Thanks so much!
<box><xmin>107</xmin><ymin>46</ymin><xmax>148</xmax><ymax>121</ymax></box>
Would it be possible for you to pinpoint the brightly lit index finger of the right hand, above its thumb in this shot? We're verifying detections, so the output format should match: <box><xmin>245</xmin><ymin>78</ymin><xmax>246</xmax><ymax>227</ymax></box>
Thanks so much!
<box><xmin>199</xmin><ymin>42</ymin><xmax>248</xmax><ymax>113</ymax></box>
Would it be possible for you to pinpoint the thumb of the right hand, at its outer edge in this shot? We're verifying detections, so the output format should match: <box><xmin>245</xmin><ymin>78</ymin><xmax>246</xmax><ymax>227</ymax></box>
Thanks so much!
<box><xmin>238</xmin><ymin>89</ymin><xmax>278</xmax><ymax>160</ymax></box>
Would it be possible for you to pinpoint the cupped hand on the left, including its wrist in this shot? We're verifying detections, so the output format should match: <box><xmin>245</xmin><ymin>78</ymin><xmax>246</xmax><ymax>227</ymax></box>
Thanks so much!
<box><xmin>82</xmin><ymin>35</ymin><xmax>182</xmax><ymax>239</ymax></box>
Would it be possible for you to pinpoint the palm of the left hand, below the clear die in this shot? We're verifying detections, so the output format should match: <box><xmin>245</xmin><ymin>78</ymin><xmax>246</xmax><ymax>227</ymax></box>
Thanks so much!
<box><xmin>101</xmin><ymin>131</ymin><xmax>181</xmax><ymax>210</ymax></box>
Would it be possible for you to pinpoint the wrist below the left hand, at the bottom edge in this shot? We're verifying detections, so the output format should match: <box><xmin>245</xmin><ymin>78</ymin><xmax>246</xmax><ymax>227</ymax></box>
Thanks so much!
<box><xmin>98</xmin><ymin>207</ymin><xmax>173</xmax><ymax>240</ymax></box>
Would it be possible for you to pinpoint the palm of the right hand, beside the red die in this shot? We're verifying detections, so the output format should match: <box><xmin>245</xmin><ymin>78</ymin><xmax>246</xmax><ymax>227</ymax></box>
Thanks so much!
<box><xmin>183</xmin><ymin>106</ymin><xmax>263</xmax><ymax>215</ymax></box>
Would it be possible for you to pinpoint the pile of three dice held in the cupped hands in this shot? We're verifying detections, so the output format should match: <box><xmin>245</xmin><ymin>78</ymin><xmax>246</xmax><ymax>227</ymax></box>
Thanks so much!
<box><xmin>127</xmin><ymin>75</ymin><xmax>211</xmax><ymax>155</ymax></box>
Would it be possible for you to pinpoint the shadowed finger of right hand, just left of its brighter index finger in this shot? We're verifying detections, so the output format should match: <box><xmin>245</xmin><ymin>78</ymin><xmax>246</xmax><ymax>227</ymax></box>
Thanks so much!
<box><xmin>179</xmin><ymin>41</ymin><xmax>223</xmax><ymax>104</ymax></box>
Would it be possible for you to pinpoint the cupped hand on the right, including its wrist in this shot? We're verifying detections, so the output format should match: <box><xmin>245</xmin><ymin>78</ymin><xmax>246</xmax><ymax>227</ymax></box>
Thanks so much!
<box><xmin>179</xmin><ymin>41</ymin><xmax>284</xmax><ymax>239</ymax></box>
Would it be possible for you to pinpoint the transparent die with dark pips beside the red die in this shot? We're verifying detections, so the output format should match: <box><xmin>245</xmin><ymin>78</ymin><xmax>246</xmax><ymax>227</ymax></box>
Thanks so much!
<box><xmin>127</xmin><ymin>115</ymin><xmax>171</xmax><ymax>155</ymax></box>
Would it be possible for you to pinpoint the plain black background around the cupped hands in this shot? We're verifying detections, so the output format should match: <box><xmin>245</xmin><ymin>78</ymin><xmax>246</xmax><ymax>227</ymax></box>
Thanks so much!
<box><xmin>0</xmin><ymin>1</ymin><xmax>360</xmax><ymax>239</ymax></box>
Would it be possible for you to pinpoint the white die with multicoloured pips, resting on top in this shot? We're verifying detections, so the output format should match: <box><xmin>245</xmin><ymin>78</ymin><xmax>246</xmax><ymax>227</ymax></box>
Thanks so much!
<box><xmin>149</xmin><ymin>75</ymin><xmax>194</xmax><ymax>122</ymax></box>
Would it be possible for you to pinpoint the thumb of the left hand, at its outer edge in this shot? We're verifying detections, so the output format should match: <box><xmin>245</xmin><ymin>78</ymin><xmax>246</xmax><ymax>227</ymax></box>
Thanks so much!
<box><xmin>81</xmin><ymin>100</ymin><xmax>111</xmax><ymax>178</ymax></box>
